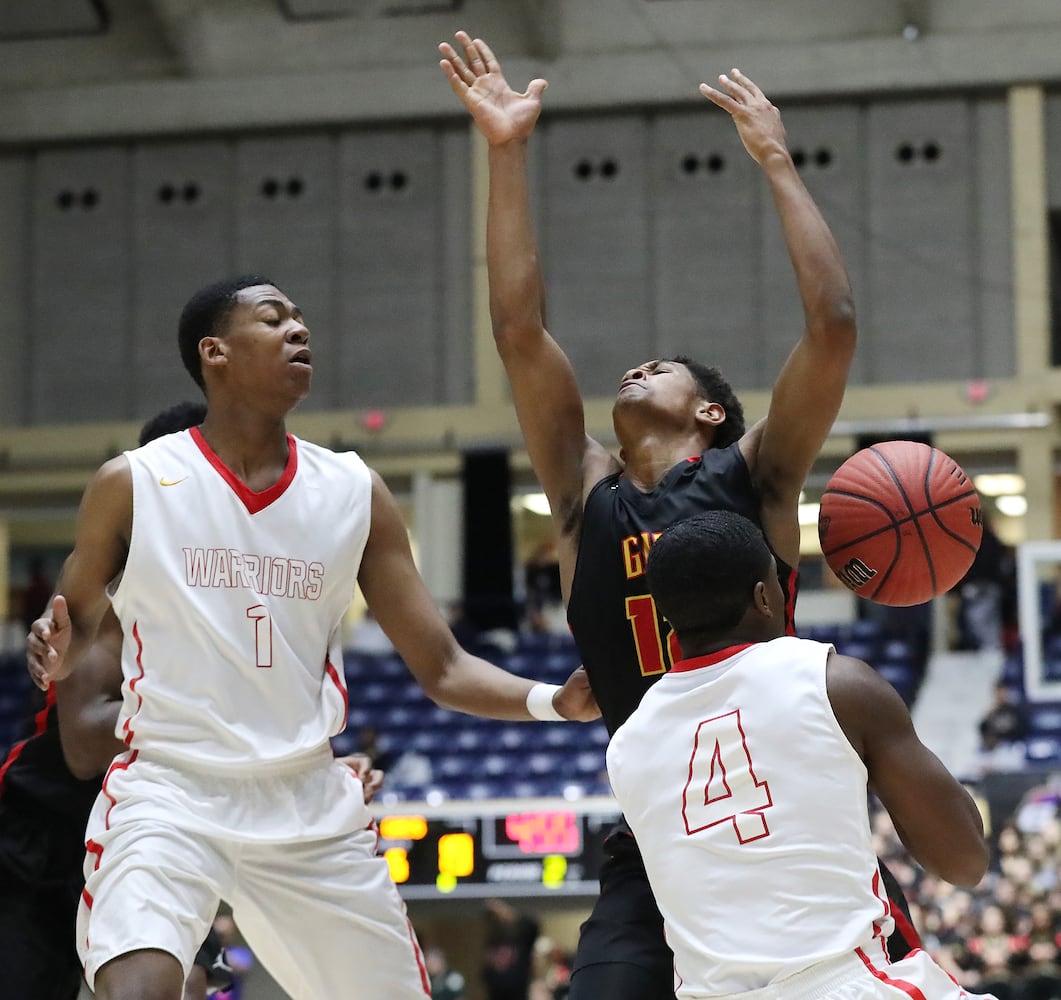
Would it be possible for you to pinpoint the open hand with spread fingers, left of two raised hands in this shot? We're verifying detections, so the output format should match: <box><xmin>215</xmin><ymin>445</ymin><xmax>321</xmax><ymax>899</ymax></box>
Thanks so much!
<box><xmin>438</xmin><ymin>31</ymin><xmax>549</xmax><ymax>145</ymax></box>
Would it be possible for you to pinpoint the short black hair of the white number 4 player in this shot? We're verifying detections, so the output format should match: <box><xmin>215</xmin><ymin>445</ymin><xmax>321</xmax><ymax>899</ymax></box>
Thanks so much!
<box><xmin>647</xmin><ymin>510</ymin><xmax>772</xmax><ymax>642</ymax></box>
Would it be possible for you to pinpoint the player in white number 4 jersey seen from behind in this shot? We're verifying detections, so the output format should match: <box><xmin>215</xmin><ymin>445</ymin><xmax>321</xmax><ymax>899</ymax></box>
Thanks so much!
<box><xmin>608</xmin><ymin>511</ymin><xmax>988</xmax><ymax>1000</ymax></box>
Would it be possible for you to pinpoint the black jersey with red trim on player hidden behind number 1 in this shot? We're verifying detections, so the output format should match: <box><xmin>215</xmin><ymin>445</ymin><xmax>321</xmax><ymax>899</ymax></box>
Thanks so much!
<box><xmin>0</xmin><ymin>687</ymin><xmax>101</xmax><ymax>888</ymax></box>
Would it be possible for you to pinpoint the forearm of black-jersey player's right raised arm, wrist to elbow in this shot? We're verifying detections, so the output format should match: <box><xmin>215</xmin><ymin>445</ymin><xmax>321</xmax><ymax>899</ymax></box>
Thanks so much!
<box><xmin>761</xmin><ymin>148</ymin><xmax>854</xmax><ymax>336</ymax></box>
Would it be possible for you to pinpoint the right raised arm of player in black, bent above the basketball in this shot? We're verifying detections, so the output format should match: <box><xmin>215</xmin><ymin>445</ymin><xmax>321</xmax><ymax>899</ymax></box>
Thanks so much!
<box><xmin>700</xmin><ymin>69</ymin><xmax>856</xmax><ymax>565</ymax></box>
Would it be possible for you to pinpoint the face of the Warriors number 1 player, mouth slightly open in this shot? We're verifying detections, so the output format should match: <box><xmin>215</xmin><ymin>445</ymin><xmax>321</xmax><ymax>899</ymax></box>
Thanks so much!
<box><xmin>224</xmin><ymin>285</ymin><xmax>313</xmax><ymax>402</ymax></box>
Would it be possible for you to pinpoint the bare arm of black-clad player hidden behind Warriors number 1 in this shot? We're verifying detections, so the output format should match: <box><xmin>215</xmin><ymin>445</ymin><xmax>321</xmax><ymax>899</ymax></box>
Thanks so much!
<box><xmin>55</xmin><ymin>610</ymin><xmax>127</xmax><ymax>779</ymax></box>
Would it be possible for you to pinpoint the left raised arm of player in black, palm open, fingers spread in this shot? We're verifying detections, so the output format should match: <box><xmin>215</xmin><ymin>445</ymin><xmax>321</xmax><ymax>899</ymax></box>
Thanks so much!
<box><xmin>439</xmin><ymin>32</ymin><xmax>618</xmax><ymax>534</ymax></box>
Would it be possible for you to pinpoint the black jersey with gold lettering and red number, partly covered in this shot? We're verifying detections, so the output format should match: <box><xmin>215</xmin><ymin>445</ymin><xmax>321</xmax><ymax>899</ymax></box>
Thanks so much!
<box><xmin>568</xmin><ymin>443</ymin><xmax>797</xmax><ymax>733</ymax></box>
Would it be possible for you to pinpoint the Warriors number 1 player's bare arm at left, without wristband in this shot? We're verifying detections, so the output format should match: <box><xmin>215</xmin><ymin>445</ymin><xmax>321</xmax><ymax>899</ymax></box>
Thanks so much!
<box><xmin>28</xmin><ymin>455</ymin><xmax>133</xmax><ymax>690</ymax></box>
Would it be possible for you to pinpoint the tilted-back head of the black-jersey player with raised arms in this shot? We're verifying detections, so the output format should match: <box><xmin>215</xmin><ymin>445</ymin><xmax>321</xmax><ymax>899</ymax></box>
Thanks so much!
<box><xmin>612</xmin><ymin>354</ymin><xmax>745</xmax><ymax>448</ymax></box>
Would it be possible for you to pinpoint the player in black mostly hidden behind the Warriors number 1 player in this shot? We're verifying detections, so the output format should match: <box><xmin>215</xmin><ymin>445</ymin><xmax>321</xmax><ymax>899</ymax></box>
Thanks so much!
<box><xmin>0</xmin><ymin>403</ymin><xmax>230</xmax><ymax>1000</ymax></box>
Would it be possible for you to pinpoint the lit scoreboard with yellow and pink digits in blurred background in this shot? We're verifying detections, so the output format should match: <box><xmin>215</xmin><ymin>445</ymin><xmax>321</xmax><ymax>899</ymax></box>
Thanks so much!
<box><xmin>375</xmin><ymin>797</ymin><xmax>620</xmax><ymax>899</ymax></box>
